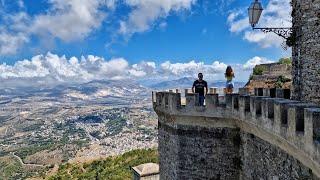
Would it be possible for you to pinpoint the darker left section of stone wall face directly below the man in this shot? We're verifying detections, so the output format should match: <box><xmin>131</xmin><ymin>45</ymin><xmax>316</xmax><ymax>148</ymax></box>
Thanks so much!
<box><xmin>159</xmin><ymin>123</ymin><xmax>240</xmax><ymax>180</ymax></box>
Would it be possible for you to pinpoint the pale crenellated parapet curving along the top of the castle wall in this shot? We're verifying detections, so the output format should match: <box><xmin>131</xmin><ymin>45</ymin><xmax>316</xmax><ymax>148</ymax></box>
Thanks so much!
<box><xmin>152</xmin><ymin>88</ymin><xmax>320</xmax><ymax>177</ymax></box>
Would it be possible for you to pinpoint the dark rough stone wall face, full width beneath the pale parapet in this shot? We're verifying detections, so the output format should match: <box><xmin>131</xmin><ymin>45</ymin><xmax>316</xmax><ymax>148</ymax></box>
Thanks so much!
<box><xmin>159</xmin><ymin>118</ymin><xmax>317</xmax><ymax>180</ymax></box>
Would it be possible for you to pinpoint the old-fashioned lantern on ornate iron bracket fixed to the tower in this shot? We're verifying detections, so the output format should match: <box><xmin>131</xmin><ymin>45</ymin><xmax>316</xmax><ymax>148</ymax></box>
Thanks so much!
<box><xmin>248</xmin><ymin>0</ymin><xmax>292</xmax><ymax>40</ymax></box>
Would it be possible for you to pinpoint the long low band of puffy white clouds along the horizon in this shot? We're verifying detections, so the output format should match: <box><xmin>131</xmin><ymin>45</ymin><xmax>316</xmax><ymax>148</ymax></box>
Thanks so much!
<box><xmin>0</xmin><ymin>53</ymin><xmax>273</xmax><ymax>88</ymax></box>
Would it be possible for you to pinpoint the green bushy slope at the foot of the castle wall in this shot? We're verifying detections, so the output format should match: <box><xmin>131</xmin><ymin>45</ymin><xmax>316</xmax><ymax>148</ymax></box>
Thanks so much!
<box><xmin>49</xmin><ymin>149</ymin><xmax>158</xmax><ymax>180</ymax></box>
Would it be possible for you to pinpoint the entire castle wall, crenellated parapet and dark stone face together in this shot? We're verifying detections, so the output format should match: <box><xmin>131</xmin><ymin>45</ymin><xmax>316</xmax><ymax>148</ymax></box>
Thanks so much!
<box><xmin>153</xmin><ymin>89</ymin><xmax>320</xmax><ymax>179</ymax></box>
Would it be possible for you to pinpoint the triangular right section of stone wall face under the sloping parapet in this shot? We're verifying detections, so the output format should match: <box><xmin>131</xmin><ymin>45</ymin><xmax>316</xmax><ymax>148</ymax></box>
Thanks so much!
<box><xmin>240</xmin><ymin>132</ymin><xmax>317</xmax><ymax>180</ymax></box>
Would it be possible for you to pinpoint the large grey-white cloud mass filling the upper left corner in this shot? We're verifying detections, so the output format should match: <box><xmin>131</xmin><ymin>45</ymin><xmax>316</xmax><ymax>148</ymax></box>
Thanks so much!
<box><xmin>0</xmin><ymin>0</ymin><xmax>111</xmax><ymax>55</ymax></box>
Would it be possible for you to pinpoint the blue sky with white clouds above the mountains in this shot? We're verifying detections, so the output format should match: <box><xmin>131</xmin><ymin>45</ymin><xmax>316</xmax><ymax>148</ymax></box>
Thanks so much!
<box><xmin>0</xmin><ymin>0</ymin><xmax>291</xmax><ymax>87</ymax></box>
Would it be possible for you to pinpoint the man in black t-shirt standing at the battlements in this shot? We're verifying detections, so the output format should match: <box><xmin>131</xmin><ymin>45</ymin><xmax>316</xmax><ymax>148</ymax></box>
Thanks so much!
<box><xmin>192</xmin><ymin>73</ymin><xmax>208</xmax><ymax>106</ymax></box>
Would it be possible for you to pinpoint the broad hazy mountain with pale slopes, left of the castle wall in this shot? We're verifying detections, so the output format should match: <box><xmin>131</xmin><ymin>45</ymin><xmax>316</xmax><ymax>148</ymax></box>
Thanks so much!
<box><xmin>0</xmin><ymin>80</ymin><xmax>151</xmax><ymax>104</ymax></box>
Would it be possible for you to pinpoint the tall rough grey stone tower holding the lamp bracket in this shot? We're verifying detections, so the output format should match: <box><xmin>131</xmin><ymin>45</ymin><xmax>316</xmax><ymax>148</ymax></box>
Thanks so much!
<box><xmin>292</xmin><ymin>0</ymin><xmax>320</xmax><ymax>104</ymax></box>
